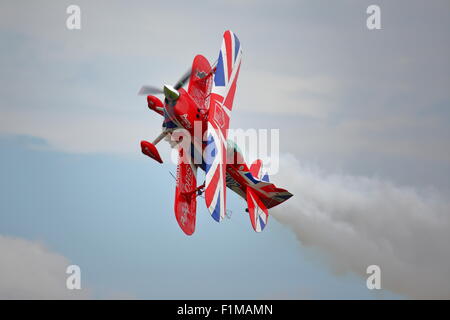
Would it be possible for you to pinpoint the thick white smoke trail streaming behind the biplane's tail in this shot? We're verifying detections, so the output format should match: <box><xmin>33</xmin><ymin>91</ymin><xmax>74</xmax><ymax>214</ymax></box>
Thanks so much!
<box><xmin>271</xmin><ymin>156</ymin><xmax>450</xmax><ymax>299</ymax></box>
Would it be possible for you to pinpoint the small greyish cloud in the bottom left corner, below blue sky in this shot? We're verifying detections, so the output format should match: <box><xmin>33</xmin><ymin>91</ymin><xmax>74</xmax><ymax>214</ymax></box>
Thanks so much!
<box><xmin>0</xmin><ymin>235</ymin><xmax>90</xmax><ymax>299</ymax></box>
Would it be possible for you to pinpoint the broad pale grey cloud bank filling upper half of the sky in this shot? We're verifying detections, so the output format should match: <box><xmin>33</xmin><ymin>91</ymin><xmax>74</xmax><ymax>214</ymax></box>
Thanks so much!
<box><xmin>0</xmin><ymin>1</ymin><xmax>450</xmax><ymax>166</ymax></box>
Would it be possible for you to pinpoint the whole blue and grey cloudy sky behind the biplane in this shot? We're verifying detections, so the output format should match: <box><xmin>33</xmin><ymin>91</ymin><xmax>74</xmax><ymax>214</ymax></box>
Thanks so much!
<box><xmin>0</xmin><ymin>0</ymin><xmax>450</xmax><ymax>299</ymax></box>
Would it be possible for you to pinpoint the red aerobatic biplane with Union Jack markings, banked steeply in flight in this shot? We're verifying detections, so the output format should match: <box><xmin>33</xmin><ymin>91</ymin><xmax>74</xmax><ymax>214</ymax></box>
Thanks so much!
<box><xmin>139</xmin><ymin>31</ymin><xmax>292</xmax><ymax>235</ymax></box>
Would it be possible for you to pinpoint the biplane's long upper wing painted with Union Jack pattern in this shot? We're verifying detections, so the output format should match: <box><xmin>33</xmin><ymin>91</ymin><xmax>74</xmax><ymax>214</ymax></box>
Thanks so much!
<box><xmin>205</xmin><ymin>30</ymin><xmax>242</xmax><ymax>221</ymax></box>
